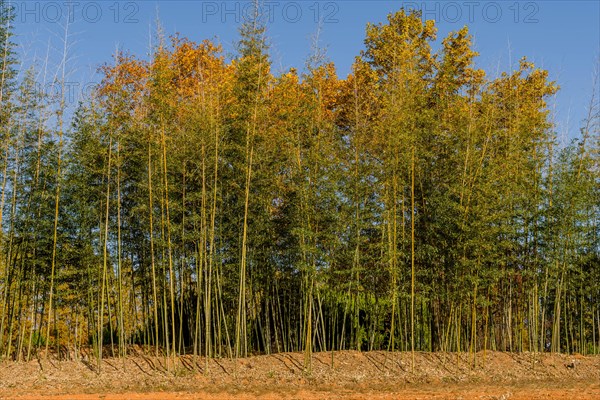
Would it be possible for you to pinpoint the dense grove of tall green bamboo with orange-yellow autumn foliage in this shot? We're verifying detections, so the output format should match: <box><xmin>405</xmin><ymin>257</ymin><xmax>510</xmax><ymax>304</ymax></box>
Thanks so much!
<box><xmin>0</xmin><ymin>2</ymin><xmax>600</xmax><ymax>365</ymax></box>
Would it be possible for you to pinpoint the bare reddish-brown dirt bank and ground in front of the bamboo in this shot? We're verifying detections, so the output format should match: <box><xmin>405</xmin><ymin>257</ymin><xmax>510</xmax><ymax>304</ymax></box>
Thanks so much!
<box><xmin>0</xmin><ymin>351</ymin><xmax>600</xmax><ymax>400</ymax></box>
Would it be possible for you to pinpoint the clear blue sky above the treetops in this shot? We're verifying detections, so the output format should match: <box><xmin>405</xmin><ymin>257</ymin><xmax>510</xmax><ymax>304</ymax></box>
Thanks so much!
<box><xmin>11</xmin><ymin>0</ymin><xmax>600</xmax><ymax>141</ymax></box>
